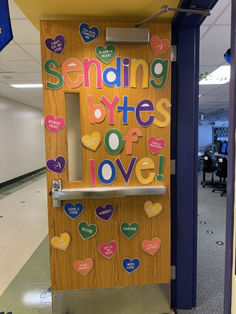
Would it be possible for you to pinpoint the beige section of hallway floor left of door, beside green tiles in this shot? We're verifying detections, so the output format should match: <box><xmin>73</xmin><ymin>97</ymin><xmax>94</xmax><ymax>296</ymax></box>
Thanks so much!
<box><xmin>0</xmin><ymin>175</ymin><xmax>48</xmax><ymax>295</ymax></box>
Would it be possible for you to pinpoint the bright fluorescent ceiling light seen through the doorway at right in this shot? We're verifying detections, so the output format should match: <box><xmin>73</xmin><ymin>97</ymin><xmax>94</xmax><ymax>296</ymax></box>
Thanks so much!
<box><xmin>199</xmin><ymin>65</ymin><xmax>230</xmax><ymax>85</ymax></box>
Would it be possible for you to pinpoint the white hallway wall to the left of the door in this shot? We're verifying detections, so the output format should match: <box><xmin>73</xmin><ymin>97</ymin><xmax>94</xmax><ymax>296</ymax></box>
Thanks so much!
<box><xmin>0</xmin><ymin>96</ymin><xmax>45</xmax><ymax>183</ymax></box>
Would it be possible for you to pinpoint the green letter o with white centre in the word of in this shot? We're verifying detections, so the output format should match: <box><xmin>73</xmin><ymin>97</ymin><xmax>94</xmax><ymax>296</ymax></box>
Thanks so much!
<box><xmin>104</xmin><ymin>129</ymin><xmax>123</xmax><ymax>155</ymax></box>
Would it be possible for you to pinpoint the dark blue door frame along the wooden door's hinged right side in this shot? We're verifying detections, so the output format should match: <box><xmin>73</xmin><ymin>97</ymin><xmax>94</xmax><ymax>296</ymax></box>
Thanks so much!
<box><xmin>171</xmin><ymin>0</ymin><xmax>218</xmax><ymax>309</ymax></box>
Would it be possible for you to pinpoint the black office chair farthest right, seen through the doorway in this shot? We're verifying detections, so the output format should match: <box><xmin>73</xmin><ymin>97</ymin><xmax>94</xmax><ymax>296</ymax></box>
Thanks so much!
<box><xmin>212</xmin><ymin>157</ymin><xmax>228</xmax><ymax>196</ymax></box>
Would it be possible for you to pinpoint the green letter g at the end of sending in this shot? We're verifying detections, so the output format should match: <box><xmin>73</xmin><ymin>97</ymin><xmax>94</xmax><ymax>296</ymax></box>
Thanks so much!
<box><xmin>151</xmin><ymin>59</ymin><xmax>169</xmax><ymax>89</ymax></box>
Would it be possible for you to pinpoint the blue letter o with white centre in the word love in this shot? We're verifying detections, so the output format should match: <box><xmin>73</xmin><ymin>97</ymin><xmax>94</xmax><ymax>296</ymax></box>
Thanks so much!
<box><xmin>98</xmin><ymin>159</ymin><xmax>116</xmax><ymax>184</ymax></box>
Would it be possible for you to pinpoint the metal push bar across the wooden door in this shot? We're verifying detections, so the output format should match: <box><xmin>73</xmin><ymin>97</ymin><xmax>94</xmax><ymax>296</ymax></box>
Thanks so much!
<box><xmin>50</xmin><ymin>180</ymin><xmax>166</xmax><ymax>207</ymax></box>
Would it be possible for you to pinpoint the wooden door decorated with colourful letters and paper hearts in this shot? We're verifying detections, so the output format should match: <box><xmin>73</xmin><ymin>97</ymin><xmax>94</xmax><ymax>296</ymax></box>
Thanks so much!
<box><xmin>41</xmin><ymin>21</ymin><xmax>171</xmax><ymax>291</ymax></box>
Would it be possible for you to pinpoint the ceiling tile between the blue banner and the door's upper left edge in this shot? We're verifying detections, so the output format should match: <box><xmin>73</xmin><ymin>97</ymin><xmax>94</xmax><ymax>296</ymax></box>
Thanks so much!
<box><xmin>12</xmin><ymin>20</ymin><xmax>40</xmax><ymax>44</ymax></box>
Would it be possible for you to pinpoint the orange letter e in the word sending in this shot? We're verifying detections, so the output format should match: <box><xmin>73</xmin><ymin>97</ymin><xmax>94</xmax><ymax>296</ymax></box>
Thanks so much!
<box><xmin>62</xmin><ymin>58</ymin><xmax>84</xmax><ymax>88</ymax></box>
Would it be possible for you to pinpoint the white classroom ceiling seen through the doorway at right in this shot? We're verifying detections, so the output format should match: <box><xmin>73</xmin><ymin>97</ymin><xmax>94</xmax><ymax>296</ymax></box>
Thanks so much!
<box><xmin>199</xmin><ymin>0</ymin><xmax>231</xmax><ymax>112</ymax></box>
